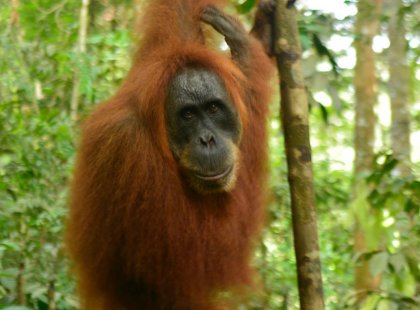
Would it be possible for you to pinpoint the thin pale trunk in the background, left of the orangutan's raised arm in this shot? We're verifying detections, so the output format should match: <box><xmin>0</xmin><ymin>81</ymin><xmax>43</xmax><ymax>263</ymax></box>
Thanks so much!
<box><xmin>70</xmin><ymin>0</ymin><xmax>90</xmax><ymax>120</ymax></box>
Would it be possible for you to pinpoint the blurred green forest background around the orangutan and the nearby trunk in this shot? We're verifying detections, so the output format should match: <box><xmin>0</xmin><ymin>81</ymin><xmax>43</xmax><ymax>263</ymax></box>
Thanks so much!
<box><xmin>0</xmin><ymin>0</ymin><xmax>420</xmax><ymax>310</ymax></box>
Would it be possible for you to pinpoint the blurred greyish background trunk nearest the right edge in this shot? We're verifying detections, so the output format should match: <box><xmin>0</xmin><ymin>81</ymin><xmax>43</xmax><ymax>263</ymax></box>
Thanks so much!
<box><xmin>388</xmin><ymin>0</ymin><xmax>411</xmax><ymax>176</ymax></box>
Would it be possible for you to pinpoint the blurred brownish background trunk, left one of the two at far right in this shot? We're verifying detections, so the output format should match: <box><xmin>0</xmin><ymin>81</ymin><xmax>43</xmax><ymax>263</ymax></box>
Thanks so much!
<box><xmin>354</xmin><ymin>0</ymin><xmax>382</xmax><ymax>301</ymax></box>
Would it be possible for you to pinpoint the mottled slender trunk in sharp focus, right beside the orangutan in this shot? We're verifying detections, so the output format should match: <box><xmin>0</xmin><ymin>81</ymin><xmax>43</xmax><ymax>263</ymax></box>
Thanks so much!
<box><xmin>274</xmin><ymin>0</ymin><xmax>324</xmax><ymax>310</ymax></box>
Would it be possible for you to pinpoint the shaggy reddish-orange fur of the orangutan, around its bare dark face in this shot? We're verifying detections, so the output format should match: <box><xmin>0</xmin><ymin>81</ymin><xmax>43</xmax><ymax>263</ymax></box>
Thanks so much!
<box><xmin>67</xmin><ymin>0</ymin><xmax>271</xmax><ymax>310</ymax></box>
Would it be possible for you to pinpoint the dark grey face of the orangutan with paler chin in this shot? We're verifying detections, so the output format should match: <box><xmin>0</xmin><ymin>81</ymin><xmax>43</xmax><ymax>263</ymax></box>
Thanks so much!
<box><xmin>165</xmin><ymin>67</ymin><xmax>241</xmax><ymax>193</ymax></box>
